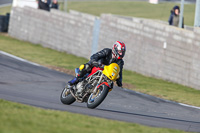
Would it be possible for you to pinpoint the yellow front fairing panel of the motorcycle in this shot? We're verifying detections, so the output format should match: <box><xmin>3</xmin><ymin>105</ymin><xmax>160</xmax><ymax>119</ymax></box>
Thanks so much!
<box><xmin>103</xmin><ymin>63</ymin><xmax>120</xmax><ymax>81</ymax></box>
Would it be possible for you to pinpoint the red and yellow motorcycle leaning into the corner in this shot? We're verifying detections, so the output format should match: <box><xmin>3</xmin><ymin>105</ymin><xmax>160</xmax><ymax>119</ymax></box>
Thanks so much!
<box><xmin>60</xmin><ymin>63</ymin><xmax>120</xmax><ymax>109</ymax></box>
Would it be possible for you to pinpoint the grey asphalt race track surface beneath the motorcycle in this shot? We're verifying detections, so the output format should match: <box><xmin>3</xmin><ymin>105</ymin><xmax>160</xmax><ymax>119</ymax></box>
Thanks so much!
<box><xmin>0</xmin><ymin>51</ymin><xmax>200</xmax><ymax>132</ymax></box>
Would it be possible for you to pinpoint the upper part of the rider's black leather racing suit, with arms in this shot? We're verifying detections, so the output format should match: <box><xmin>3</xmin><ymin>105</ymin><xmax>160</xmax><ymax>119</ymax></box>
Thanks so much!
<box><xmin>81</xmin><ymin>48</ymin><xmax>124</xmax><ymax>87</ymax></box>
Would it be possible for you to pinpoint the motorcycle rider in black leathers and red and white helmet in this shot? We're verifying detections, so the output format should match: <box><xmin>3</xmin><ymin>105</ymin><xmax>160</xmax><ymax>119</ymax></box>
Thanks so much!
<box><xmin>68</xmin><ymin>41</ymin><xmax>126</xmax><ymax>87</ymax></box>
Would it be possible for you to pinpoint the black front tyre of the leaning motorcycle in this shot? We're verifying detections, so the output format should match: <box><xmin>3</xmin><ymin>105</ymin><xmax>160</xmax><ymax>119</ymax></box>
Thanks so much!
<box><xmin>87</xmin><ymin>85</ymin><xmax>109</xmax><ymax>109</ymax></box>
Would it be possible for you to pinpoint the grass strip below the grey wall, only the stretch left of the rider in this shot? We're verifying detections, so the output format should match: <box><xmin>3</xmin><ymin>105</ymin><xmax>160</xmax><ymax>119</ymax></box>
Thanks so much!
<box><xmin>0</xmin><ymin>35</ymin><xmax>88</xmax><ymax>69</ymax></box>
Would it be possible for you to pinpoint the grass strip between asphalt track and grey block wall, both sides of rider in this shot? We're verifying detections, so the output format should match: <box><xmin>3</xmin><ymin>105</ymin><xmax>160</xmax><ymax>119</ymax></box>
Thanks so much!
<box><xmin>0</xmin><ymin>34</ymin><xmax>200</xmax><ymax>106</ymax></box>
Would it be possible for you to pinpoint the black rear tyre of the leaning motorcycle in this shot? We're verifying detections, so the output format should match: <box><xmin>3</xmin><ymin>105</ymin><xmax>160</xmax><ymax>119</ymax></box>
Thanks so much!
<box><xmin>60</xmin><ymin>88</ymin><xmax>76</xmax><ymax>105</ymax></box>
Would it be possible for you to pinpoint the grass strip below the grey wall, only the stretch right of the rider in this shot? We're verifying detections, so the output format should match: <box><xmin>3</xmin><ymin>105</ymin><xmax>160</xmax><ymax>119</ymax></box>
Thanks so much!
<box><xmin>123</xmin><ymin>71</ymin><xmax>200</xmax><ymax>107</ymax></box>
